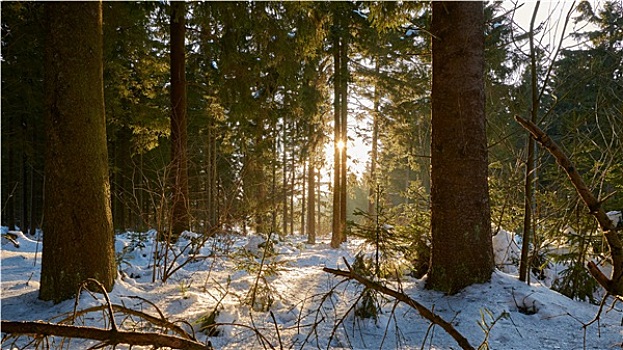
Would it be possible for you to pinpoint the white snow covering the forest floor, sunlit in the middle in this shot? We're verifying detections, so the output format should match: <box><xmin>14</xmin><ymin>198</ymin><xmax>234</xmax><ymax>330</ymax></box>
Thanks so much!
<box><xmin>0</xmin><ymin>228</ymin><xmax>623</xmax><ymax>349</ymax></box>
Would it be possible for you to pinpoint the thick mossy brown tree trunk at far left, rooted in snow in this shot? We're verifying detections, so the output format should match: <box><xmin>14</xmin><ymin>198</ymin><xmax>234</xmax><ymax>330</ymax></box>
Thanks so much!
<box><xmin>39</xmin><ymin>2</ymin><xmax>116</xmax><ymax>302</ymax></box>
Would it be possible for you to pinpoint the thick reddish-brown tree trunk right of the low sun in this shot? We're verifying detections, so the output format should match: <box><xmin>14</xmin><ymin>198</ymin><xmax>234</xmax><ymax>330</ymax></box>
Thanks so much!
<box><xmin>427</xmin><ymin>2</ymin><xmax>494</xmax><ymax>293</ymax></box>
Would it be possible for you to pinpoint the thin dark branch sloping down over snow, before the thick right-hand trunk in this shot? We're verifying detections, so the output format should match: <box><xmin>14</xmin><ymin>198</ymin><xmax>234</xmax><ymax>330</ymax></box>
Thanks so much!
<box><xmin>322</xmin><ymin>261</ymin><xmax>474</xmax><ymax>349</ymax></box>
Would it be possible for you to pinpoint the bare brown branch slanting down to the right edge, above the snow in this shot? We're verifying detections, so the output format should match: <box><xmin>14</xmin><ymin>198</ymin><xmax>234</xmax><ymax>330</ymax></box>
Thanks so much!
<box><xmin>515</xmin><ymin>116</ymin><xmax>623</xmax><ymax>296</ymax></box>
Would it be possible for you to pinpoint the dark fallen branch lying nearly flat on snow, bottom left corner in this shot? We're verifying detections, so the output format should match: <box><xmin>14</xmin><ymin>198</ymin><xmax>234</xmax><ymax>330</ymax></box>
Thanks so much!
<box><xmin>0</xmin><ymin>321</ymin><xmax>210</xmax><ymax>350</ymax></box>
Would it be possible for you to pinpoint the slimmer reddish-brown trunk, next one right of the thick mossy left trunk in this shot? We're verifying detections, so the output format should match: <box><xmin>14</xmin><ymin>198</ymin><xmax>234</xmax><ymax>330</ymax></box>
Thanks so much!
<box><xmin>169</xmin><ymin>1</ymin><xmax>190</xmax><ymax>242</ymax></box>
